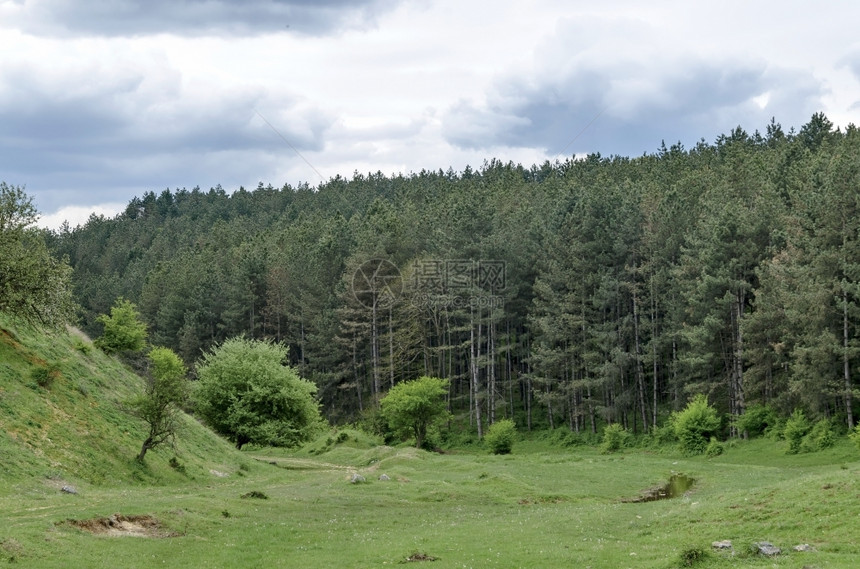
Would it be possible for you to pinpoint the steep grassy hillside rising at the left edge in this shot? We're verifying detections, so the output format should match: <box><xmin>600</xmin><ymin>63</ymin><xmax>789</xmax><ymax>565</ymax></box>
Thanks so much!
<box><xmin>0</xmin><ymin>319</ymin><xmax>242</xmax><ymax>492</ymax></box>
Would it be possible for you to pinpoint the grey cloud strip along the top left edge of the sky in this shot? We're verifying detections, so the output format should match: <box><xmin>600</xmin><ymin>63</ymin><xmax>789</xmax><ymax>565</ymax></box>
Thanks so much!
<box><xmin>7</xmin><ymin>0</ymin><xmax>404</xmax><ymax>36</ymax></box>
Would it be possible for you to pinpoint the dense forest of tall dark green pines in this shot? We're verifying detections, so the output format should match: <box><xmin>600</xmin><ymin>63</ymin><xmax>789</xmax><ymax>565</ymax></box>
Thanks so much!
<box><xmin>52</xmin><ymin>114</ymin><xmax>860</xmax><ymax>433</ymax></box>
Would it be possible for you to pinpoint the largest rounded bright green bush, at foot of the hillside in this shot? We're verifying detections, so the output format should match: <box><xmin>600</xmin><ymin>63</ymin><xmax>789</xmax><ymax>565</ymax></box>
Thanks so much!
<box><xmin>194</xmin><ymin>338</ymin><xmax>321</xmax><ymax>448</ymax></box>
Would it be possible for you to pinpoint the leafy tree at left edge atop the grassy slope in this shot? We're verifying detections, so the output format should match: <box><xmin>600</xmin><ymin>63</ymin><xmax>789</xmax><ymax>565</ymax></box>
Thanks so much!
<box><xmin>0</xmin><ymin>182</ymin><xmax>76</xmax><ymax>328</ymax></box>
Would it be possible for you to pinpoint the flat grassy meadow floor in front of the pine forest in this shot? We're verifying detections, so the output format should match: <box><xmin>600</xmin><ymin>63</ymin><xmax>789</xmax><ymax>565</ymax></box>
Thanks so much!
<box><xmin>0</xmin><ymin>432</ymin><xmax>860</xmax><ymax>568</ymax></box>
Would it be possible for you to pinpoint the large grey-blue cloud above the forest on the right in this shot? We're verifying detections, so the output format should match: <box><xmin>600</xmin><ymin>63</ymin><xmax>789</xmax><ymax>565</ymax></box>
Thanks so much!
<box><xmin>444</xmin><ymin>61</ymin><xmax>821</xmax><ymax>156</ymax></box>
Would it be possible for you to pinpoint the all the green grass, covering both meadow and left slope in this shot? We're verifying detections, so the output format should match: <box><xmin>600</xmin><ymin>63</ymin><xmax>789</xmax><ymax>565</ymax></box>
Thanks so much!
<box><xmin>0</xmin><ymin>318</ymin><xmax>860</xmax><ymax>569</ymax></box>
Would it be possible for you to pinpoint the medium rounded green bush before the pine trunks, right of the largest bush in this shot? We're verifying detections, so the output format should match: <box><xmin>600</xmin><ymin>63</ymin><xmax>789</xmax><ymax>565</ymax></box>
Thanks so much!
<box><xmin>379</xmin><ymin>376</ymin><xmax>448</xmax><ymax>448</ymax></box>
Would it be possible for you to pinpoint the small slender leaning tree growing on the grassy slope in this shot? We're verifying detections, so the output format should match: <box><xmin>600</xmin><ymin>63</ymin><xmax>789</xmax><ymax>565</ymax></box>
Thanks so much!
<box><xmin>128</xmin><ymin>348</ymin><xmax>189</xmax><ymax>462</ymax></box>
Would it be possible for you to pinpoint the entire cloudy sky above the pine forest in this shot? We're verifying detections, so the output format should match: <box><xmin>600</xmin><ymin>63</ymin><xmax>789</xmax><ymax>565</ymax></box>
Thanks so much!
<box><xmin>0</xmin><ymin>0</ymin><xmax>860</xmax><ymax>227</ymax></box>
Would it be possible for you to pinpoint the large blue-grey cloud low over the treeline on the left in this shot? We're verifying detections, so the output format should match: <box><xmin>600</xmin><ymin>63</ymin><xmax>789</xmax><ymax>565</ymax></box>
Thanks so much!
<box><xmin>0</xmin><ymin>65</ymin><xmax>334</xmax><ymax>212</ymax></box>
